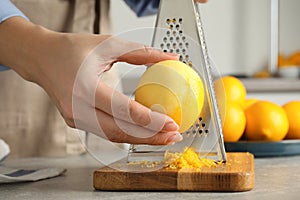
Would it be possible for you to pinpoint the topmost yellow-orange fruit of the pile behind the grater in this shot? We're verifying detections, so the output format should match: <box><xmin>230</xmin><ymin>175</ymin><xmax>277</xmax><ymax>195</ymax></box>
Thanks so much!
<box><xmin>215</xmin><ymin>76</ymin><xmax>246</xmax><ymax>106</ymax></box>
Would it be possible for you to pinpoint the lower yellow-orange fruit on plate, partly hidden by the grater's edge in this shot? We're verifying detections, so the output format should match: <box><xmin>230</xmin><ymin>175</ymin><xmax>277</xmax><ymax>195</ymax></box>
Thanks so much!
<box><xmin>223</xmin><ymin>102</ymin><xmax>246</xmax><ymax>142</ymax></box>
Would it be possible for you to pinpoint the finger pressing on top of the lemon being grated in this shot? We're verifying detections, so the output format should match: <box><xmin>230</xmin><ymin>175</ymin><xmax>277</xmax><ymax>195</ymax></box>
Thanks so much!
<box><xmin>117</xmin><ymin>46</ymin><xmax>179</xmax><ymax>65</ymax></box>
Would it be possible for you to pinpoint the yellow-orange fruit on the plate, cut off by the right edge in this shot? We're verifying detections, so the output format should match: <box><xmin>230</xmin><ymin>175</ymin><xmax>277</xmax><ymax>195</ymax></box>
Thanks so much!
<box><xmin>282</xmin><ymin>101</ymin><xmax>300</xmax><ymax>139</ymax></box>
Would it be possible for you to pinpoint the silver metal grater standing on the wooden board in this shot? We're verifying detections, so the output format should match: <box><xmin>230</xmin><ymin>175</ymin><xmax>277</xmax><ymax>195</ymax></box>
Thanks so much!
<box><xmin>128</xmin><ymin>0</ymin><xmax>226</xmax><ymax>162</ymax></box>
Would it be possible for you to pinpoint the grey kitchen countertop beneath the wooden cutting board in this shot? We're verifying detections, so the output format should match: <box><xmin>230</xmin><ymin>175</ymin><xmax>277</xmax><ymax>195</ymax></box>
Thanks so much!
<box><xmin>0</xmin><ymin>155</ymin><xmax>300</xmax><ymax>200</ymax></box>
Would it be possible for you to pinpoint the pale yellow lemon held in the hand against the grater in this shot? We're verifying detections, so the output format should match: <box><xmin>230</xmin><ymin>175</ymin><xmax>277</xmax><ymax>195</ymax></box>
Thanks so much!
<box><xmin>135</xmin><ymin>60</ymin><xmax>204</xmax><ymax>132</ymax></box>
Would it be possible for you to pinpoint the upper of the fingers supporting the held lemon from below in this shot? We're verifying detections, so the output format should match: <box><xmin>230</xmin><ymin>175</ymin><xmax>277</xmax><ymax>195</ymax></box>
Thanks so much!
<box><xmin>95</xmin><ymin>83</ymin><xmax>179</xmax><ymax>132</ymax></box>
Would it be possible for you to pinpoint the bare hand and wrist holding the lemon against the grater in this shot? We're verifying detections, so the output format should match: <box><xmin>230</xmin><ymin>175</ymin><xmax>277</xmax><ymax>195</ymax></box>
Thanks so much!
<box><xmin>0</xmin><ymin>17</ymin><xmax>182</xmax><ymax>145</ymax></box>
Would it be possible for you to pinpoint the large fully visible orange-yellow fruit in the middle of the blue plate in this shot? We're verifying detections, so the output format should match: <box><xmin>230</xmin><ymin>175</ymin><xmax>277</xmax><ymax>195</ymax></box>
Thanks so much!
<box><xmin>245</xmin><ymin>100</ymin><xmax>289</xmax><ymax>141</ymax></box>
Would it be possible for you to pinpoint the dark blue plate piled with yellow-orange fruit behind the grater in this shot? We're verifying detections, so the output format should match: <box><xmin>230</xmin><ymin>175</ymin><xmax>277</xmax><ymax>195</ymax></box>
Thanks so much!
<box><xmin>216</xmin><ymin>76</ymin><xmax>300</xmax><ymax>157</ymax></box>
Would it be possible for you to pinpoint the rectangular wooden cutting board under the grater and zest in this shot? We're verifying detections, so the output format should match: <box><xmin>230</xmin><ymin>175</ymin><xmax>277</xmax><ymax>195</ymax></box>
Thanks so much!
<box><xmin>93</xmin><ymin>153</ymin><xmax>255</xmax><ymax>191</ymax></box>
